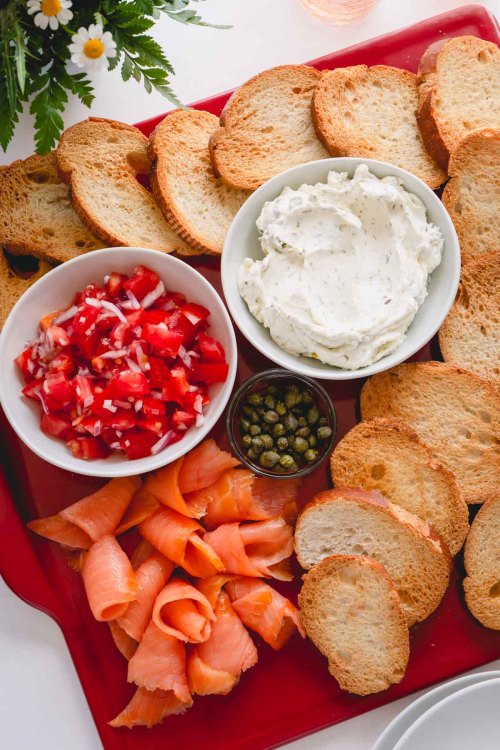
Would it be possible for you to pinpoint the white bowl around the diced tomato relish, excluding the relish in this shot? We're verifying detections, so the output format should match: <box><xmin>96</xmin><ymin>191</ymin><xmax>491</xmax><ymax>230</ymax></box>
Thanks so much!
<box><xmin>0</xmin><ymin>247</ymin><xmax>237</xmax><ymax>477</ymax></box>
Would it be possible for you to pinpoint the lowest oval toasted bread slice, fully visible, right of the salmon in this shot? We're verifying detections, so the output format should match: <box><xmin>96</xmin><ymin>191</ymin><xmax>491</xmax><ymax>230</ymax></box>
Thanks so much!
<box><xmin>299</xmin><ymin>555</ymin><xmax>410</xmax><ymax>695</ymax></box>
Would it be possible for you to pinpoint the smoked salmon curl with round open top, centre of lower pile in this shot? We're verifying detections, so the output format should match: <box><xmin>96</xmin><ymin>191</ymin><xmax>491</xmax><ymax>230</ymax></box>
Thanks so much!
<box><xmin>152</xmin><ymin>578</ymin><xmax>215</xmax><ymax>643</ymax></box>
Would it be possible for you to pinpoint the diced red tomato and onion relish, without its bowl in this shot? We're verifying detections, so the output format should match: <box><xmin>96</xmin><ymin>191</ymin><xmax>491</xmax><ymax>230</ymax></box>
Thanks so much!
<box><xmin>16</xmin><ymin>266</ymin><xmax>229</xmax><ymax>459</ymax></box>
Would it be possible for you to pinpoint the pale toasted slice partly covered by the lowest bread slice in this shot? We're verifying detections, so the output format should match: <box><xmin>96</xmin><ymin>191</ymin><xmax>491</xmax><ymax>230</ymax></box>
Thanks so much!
<box><xmin>295</xmin><ymin>488</ymin><xmax>451</xmax><ymax>625</ymax></box>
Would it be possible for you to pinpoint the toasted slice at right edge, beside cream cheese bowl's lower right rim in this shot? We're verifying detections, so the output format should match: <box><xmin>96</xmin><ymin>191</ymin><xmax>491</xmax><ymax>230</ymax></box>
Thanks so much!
<box><xmin>439</xmin><ymin>250</ymin><xmax>500</xmax><ymax>385</ymax></box>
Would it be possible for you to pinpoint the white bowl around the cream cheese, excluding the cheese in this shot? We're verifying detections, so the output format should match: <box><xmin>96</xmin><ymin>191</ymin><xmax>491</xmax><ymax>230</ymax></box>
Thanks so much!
<box><xmin>221</xmin><ymin>158</ymin><xmax>460</xmax><ymax>380</ymax></box>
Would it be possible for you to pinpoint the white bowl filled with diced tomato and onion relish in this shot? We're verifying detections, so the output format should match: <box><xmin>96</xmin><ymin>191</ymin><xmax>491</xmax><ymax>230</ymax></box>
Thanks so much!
<box><xmin>0</xmin><ymin>247</ymin><xmax>237</xmax><ymax>477</ymax></box>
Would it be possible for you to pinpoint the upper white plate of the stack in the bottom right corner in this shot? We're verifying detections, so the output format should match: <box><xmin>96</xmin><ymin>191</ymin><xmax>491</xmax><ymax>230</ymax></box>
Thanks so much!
<box><xmin>394</xmin><ymin>678</ymin><xmax>500</xmax><ymax>750</ymax></box>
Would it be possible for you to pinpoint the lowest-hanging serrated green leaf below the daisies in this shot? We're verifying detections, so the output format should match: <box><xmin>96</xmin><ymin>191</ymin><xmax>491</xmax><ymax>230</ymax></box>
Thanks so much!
<box><xmin>30</xmin><ymin>65</ymin><xmax>68</xmax><ymax>154</ymax></box>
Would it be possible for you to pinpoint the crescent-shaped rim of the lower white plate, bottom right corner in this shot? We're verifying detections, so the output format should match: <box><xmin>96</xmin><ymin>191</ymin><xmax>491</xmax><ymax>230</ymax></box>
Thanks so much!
<box><xmin>372</xmin><ymin>671</ymin><xmax>500</xmax><ymax>750</ymax></box>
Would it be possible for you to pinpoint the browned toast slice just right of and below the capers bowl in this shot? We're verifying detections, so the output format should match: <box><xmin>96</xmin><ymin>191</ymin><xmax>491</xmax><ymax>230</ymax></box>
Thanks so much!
<box><xmin>330</xmin><ymin>419</ymin><xmax>469</xmax><ymax>555</ymax></box>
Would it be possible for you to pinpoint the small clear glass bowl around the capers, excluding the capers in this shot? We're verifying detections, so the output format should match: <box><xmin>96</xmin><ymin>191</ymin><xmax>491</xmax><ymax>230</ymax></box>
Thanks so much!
<box><xmin>226</xmin><ymin>368</ymin><xmax>337</xmax><ymax>479</ymax></box>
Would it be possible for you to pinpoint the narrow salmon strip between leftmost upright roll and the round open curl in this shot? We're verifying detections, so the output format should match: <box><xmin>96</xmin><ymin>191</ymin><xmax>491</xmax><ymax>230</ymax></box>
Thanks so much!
<box><xmin>117</xmin><ymin>552</ymin><xmax>175</xmax><ymax>641</ymax></box>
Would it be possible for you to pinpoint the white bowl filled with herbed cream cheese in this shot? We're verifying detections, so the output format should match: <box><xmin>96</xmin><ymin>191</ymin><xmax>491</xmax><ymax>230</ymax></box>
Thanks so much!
<box><xmin>221</xmin><ymin>158</ymin><xmax>460</xmax><ymax>380</ymax></box>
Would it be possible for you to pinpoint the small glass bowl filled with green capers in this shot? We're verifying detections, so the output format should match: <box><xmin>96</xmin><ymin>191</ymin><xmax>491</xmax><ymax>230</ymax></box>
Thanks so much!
<box><xmin>227</xmin><ymin>369</ymin><xmax>336</xmax><ymax>479</ymax></box>
